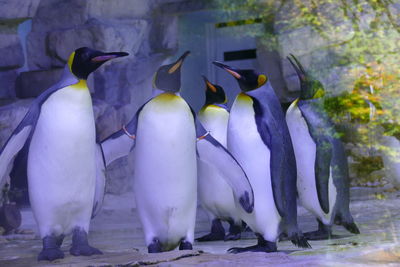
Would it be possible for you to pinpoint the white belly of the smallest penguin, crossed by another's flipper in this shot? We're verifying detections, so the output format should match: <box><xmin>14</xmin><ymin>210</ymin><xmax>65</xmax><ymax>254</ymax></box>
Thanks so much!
<box><xmin>198</xmin><ymin>106</ymin><xmax>240</xmax><ymax>223</ymax></box>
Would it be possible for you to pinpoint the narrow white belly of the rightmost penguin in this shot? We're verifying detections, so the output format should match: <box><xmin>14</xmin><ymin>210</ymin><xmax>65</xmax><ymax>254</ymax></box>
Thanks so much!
<box><xmin>286</xmin><ymin>105</ymin><xmax>336</xmax><ymax>224</ymax></box>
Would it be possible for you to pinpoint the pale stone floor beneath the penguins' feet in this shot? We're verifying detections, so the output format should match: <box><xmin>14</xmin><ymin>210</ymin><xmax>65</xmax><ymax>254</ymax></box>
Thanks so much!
<box><xmin>0</xmin><ymin>188</ymin><xmax>400</xmax><ymax>267</ymax></box>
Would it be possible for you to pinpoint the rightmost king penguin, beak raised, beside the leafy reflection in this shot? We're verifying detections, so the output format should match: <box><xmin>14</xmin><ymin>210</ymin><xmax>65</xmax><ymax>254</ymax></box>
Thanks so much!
<box><xmin>286</xmin><ymin>55</ymin><xmax>360</xmax><ymax>240</ymax></box>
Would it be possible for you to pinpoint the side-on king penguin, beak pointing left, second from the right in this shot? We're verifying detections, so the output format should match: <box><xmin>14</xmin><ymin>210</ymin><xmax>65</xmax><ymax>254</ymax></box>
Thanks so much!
<box><xmin>213</xmin><ymin>61</ymin><xmax>309</xmax><ymax>253</ymax></box>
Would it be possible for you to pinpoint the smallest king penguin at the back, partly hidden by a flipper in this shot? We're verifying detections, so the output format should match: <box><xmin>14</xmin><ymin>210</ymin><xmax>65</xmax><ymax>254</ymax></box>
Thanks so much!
<box><xmin>196</xmin><ymin>76</ymin><xmax>242</xmax><ymax>242</ymax></box>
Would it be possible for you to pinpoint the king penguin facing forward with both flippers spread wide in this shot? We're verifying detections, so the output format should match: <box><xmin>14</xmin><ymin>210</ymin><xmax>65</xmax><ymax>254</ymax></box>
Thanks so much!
<box><xmin>97</xmin><ymin>51</ymin><xmax>254</xmax><ymax>253</ymax></box>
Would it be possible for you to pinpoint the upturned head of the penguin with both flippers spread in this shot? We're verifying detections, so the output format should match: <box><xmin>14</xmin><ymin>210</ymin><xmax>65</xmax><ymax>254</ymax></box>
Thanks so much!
<box><xmin>153</xmin><ymin>51</ymin><xmax>190</xmax><ymax>93</ymax></box>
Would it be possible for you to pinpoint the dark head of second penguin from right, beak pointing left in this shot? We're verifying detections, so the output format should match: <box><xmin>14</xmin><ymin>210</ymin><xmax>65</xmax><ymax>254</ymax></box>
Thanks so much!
<box><xmin>213</xmin><ymin>61</ymin><xmax>268</xmax><ymax>92</ymax></box>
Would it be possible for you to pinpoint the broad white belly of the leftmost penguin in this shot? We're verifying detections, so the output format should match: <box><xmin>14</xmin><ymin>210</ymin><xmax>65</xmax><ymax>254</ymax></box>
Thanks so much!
<box><xmin>28</xmin><ymin>87</ymin><xmax>96</xmax><ymax>237</ymax></box>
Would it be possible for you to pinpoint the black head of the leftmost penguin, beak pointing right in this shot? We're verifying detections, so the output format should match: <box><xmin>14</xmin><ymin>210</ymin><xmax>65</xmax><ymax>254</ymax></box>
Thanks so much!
<box><xmin>68</xmin><ymin>47</ymin><xmax>129</xmax><ymax>80</ymax></box>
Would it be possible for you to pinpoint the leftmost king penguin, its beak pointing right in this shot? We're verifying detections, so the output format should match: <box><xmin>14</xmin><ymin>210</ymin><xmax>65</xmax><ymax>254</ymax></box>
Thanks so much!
<box><xmin>0</xmin><ymin>47</ymin><xmax>128</xmax><ymax>261</ymax></box>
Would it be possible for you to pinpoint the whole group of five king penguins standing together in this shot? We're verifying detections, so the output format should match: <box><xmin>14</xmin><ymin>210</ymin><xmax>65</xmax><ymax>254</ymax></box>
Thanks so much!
<box><xmin>0</xmin><ymin>47</ymin><xmax>359</xmax><ymax>261</ymax></box>
